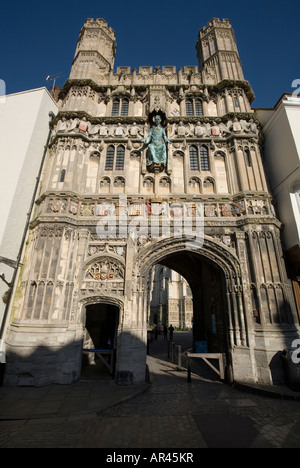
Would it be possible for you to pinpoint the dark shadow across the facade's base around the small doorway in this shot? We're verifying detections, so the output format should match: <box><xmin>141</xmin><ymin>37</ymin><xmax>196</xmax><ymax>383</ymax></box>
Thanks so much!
<box><xmin>3</xmin><ymin>332</ymin><xmax>148</xmax><ymax>387</ymax></box>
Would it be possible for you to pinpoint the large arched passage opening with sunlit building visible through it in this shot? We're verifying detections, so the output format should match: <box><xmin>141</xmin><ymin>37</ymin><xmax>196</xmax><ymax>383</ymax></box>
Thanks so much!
<box><xmin>147</xmin><ymin>251</ymin><xmax>230</xmax><ymax>378</ymax></box>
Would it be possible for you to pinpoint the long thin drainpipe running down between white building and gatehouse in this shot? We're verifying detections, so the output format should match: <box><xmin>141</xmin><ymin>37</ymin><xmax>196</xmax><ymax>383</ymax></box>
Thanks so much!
<box><xmin>0</xmin><ymin>111</ymin><xmax>55</xmax><ymax>372</ymax></box>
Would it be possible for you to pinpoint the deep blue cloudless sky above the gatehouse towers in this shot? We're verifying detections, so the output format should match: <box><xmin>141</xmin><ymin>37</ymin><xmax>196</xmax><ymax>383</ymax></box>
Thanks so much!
<box><xmin>0</xmin><ymin>0</ymin><xmax>300</xmax><ymax>108</ymax></box>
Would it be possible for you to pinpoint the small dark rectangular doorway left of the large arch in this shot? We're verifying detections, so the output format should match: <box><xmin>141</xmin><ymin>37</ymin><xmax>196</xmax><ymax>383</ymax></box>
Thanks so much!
<box><xmin>81</xmin><ymin>303</ymin><xmax>119</xmax><ymax>379</ymax></box>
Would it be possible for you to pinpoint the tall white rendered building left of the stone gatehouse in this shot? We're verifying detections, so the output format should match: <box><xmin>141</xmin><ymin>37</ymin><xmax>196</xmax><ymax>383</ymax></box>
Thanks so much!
<box><xmin>0</xmin><ymin>88</ymin><xmax>57</xmax><ymax>361</ymax></box>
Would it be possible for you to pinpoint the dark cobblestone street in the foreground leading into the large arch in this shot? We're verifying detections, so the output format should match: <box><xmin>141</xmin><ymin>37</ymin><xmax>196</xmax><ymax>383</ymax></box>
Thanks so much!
<box><xmin>0</xmin><ymin>330</ymin><xmax>300</xmax><ymax>449</ymax></box>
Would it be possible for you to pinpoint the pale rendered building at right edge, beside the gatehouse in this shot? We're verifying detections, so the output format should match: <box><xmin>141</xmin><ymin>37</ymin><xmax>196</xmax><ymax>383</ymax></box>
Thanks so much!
<box><xmin>256</xmin><ymin>94</ymin><xmax>300</xmax><ymax>314</ymax></box>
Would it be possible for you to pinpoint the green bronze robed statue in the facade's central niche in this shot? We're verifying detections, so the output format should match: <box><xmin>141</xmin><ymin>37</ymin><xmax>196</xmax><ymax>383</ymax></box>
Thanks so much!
<box><xmin>142</xmin><ymin>115</ymin><xmax>172</xmax><ymax>166</ymax></box>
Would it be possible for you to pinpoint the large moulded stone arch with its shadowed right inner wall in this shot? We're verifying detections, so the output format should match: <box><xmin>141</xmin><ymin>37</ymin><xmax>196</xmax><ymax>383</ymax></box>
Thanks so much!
<box><xmin>134</xmin><ymin>237</ymin><xmax>256</xmax><ymax>381</ymax></box>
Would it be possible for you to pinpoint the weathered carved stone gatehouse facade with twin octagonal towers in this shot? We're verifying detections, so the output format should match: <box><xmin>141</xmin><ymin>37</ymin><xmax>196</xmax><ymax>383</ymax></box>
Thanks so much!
<box><xmin>6</xmin><ymin>19</ymin><xmax>299</xmax><ymax>385</ymax></box>
